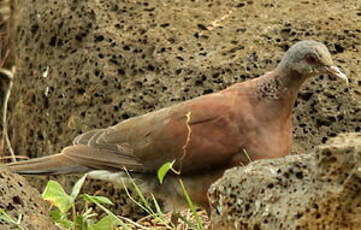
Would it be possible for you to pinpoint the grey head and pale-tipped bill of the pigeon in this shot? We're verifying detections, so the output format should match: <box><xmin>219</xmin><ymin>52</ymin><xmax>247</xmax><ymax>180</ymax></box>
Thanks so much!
<box><xmin>278</xmin><ymin>40</ymin><xmax>348</xmax><ymax>83</ymax></box>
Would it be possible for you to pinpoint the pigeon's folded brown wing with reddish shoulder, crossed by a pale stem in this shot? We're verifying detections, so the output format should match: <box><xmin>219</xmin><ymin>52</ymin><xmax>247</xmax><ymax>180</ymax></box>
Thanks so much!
<box><xmin>63</xmin><ymin>90</ymin><xmax>239</xmax><ymax>172</ymax></box>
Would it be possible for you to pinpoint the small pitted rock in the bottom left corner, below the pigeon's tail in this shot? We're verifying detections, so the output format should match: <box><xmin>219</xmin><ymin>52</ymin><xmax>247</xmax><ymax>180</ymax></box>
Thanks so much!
<box><xmin>0</xmin><ymin>165</ymin><xmax>59</xmax><ymax>230</ymax></box>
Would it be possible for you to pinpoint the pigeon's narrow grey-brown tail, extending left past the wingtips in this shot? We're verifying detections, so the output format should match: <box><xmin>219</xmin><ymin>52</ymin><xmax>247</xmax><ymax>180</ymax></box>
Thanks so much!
<box><xmin>7</xmin><ymin>153</ymin><xmax>90</xmax><ymax>175</ymax></box>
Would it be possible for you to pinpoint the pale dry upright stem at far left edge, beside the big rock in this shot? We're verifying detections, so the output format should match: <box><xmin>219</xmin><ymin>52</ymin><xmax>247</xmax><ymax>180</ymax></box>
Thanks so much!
<box><xmin>0</xmin><ymin>67</ymin><xmax>16</xmax><ymax>162</ymax></box>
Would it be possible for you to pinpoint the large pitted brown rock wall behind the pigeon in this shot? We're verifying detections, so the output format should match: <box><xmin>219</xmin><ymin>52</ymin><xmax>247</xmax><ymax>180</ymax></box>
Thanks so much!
<box><xmin>1</xmin><ymin>0</ymin><xmax>361</xmax><ymax>223</ymax></box>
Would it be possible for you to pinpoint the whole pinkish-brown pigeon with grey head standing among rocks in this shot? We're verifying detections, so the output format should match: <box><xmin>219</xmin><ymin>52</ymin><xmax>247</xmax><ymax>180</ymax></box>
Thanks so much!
<box><xmin>9</xmin><ymin>41</ymin><xmax>347</xmax><ymax>210</ymax></box>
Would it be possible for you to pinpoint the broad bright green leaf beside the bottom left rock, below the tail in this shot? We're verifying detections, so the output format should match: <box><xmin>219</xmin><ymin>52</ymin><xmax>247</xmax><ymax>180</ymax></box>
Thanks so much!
<box><xmin>42</xmin><ymin>180</ymin><xmax>74</xmax><ymax>213</ymax></box>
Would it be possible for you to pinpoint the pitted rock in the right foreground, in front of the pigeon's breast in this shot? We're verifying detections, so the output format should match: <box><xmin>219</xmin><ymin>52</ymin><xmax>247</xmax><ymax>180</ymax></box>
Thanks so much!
<box><xmin>209</xmin><ymin>133</ymin><xmax>361</xmax><ymax>230</ymax></box>
